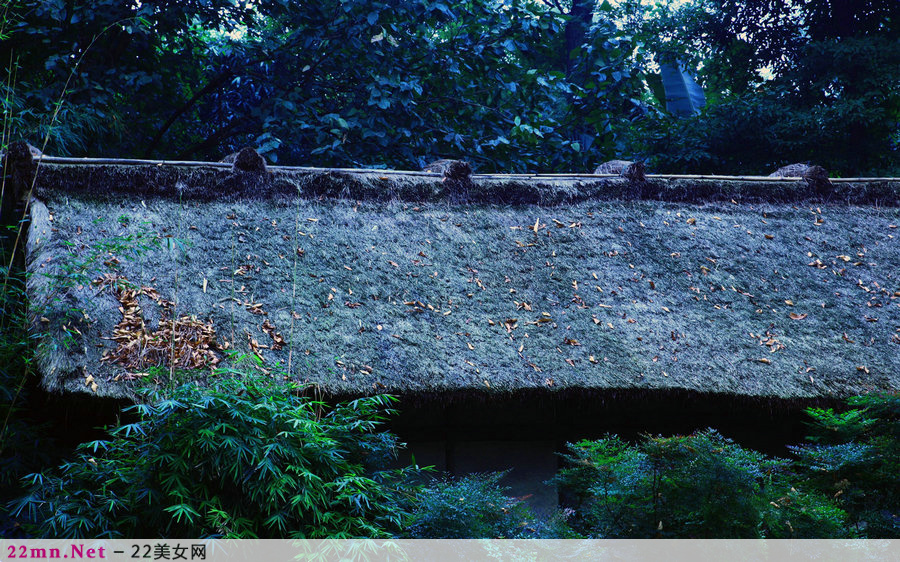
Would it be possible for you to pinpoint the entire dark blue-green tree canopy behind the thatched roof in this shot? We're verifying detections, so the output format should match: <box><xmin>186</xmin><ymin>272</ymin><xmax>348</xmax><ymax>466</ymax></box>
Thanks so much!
<box><xmin>0</xmin><ymin>0</ymin><xmax>900</xmax><ymax>175</ymax></box>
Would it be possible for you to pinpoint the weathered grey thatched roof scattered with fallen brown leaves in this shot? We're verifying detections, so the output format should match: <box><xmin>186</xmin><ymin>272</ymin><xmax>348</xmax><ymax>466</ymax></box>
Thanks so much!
<box><xmin>15</xmin><ymin>160</ymin><xmax>900</xmax><ymax>398</ymax></box>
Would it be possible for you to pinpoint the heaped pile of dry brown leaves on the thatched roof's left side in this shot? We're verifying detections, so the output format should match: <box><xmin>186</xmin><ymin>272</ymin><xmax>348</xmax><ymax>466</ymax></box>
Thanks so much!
<box><xmin>94</xmin><ymin>275</ymin><xmax>222</xmax><ymax>369</ymax></box>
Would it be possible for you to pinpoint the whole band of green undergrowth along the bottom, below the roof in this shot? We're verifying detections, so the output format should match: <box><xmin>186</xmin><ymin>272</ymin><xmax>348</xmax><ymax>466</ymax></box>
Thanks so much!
<box><xmin>7</xmin><ymin>356</ymin><xmax>900</xmax><ymax>538</ymax></box>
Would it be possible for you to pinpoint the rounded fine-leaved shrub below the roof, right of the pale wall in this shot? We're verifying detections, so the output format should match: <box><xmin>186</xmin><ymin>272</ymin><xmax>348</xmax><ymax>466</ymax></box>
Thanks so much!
<box><xmin>555</xmin><ymin>429</ymin><xmax>842</xmax><ymax>538</ymax></box>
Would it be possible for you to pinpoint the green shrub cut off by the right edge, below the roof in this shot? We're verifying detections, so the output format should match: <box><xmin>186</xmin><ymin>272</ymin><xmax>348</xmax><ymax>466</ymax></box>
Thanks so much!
<box><xmin>792</xmin><ymin>394</ymin><xmax>900</xmax><ymax>538</ymax></box>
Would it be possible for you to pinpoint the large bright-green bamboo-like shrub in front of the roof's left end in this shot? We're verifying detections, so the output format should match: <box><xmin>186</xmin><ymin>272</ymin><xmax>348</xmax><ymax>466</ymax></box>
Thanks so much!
<box><xmin>15</xmin><ymin>379</ymin><xmax>418</xmax><ymax>538</ymax></box>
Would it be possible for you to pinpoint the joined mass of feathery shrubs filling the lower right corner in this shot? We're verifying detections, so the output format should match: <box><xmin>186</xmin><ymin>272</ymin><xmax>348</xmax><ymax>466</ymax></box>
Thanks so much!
<box><xmin>555</xmin><ymin>394</ymin><xmax>900</xmax><ymax>538</ymax></box>
